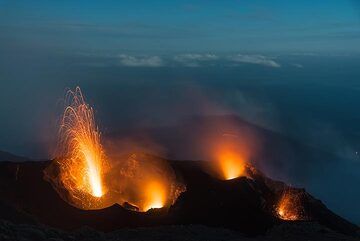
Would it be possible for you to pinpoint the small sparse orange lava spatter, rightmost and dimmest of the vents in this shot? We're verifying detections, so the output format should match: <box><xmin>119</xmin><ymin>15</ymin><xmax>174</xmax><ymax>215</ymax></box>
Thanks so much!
<box><xmin>276</xmin><ymin>190</ymin><xmax>306</xmax><ymax>221</ymax></box>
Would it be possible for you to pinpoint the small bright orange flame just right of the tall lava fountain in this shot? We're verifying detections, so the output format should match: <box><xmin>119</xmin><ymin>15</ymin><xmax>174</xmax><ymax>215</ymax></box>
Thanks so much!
<box><xmin>144</xmin><ymin>181</ymin><xmax>167</xmax><ymax>211</ymax></box>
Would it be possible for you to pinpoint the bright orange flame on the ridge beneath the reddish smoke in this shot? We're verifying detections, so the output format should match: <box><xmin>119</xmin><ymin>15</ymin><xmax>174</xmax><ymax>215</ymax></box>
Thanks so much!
<box><xmin>218</xmin><ymin>150</ymin><xmax>245</xmax><ymax>180</ymax></box>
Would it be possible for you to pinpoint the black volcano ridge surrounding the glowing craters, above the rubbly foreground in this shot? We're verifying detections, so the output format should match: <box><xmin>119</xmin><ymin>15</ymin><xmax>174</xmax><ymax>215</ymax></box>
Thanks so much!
<box><xmin>0</xmin><ymin>156</ymin><xmax>359</xmax><ymax>239</ymax></box>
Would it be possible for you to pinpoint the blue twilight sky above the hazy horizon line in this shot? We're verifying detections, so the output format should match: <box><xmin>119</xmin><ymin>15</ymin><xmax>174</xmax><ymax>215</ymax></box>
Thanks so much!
<box><xmin>0</xmin><ymin>0</ymin><xmax>360</xmax><ymax>54</ymax></box>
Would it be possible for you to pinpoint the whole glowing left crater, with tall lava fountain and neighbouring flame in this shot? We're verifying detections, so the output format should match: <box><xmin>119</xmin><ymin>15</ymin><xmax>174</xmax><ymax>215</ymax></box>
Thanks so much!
<box><xmin>44</xmin><ymin>87</ymin><xmax>185</xmax><ymax>212</ymax></box>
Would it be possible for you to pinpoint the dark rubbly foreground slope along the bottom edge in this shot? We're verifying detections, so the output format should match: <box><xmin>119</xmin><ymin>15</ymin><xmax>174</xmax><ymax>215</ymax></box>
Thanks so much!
<box><xmin>0</xmin><ymin>220</ymin><xmax>359</xmax><ymax>241</ymax></box>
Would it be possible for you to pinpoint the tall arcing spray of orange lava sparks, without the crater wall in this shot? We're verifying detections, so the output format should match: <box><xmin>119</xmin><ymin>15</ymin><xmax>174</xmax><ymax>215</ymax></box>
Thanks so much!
<box><xmin>59</xmin><ymin>87</ymin><xmax>105</xmax><ymax>197</ymax></box>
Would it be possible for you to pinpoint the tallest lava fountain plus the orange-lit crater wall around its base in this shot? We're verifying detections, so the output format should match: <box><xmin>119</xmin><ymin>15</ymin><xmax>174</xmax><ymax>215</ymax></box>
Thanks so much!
<box><xmin>45</xmin><ymin>87</ymin><xmax>111</xmax><ymax>209</ymax></box>
